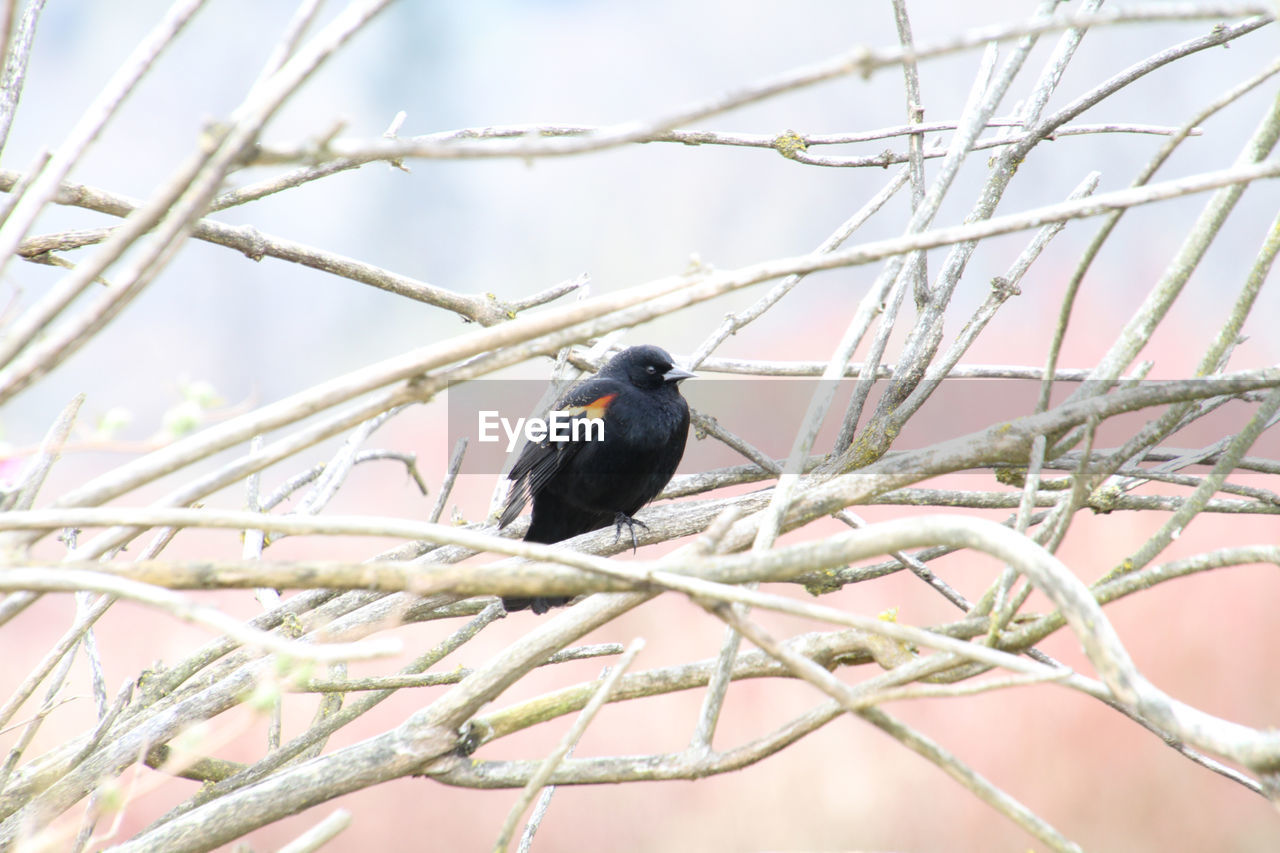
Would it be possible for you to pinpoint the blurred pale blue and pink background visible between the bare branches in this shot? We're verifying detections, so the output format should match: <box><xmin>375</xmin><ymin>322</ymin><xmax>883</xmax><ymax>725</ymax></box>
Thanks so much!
<box><xmin>0</xmin><ymin>0</ymin><xmax>1280</xmax><ymax>850</ymax></box>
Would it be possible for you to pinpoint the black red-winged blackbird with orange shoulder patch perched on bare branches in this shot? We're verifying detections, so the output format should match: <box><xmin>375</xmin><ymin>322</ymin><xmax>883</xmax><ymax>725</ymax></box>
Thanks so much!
<box><xmin>498</xmin><ymin>346</ymin><xmax>694</xmax><ymax>613</ymax></box>
